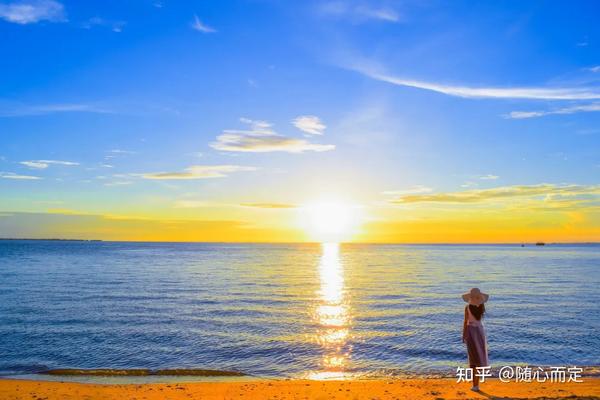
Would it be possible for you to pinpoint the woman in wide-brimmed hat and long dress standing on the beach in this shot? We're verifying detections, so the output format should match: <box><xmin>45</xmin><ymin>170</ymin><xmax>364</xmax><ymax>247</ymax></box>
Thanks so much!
<box><xmin>462</xmin><ymin>288</ymin><xmax>490</xmax><ymax>392</ymax></box>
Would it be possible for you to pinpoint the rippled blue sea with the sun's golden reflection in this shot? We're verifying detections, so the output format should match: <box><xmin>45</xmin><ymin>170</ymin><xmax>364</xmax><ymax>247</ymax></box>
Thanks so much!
<box><xmin>0</xmin><ymin>241</ymin><xmax>600</xmax><ymax>378</ymax></box>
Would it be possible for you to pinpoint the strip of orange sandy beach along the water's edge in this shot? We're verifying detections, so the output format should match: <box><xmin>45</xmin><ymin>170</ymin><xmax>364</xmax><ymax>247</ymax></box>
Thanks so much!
<box><xmin>0</xmin><ymin>378</ymin><xmax>600</xmax><ymax>400</ymax></box>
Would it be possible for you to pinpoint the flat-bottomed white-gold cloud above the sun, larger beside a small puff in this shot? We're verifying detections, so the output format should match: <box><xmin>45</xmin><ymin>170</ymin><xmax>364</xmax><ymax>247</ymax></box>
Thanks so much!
<box><xmin>210</xmin><ymin>118</ymin><xmax>335</xmax><ymax>153</ymax></box>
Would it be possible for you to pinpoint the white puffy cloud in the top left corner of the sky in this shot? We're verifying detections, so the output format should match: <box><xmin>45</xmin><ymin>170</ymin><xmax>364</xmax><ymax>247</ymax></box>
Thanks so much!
<box><xmin>0</xmin><ymin>0</ymin><xmax>67</xmax><ymax>25</ymax></box>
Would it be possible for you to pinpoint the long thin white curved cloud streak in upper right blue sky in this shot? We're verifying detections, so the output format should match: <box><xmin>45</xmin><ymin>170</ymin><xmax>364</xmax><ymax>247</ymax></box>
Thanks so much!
<box><xmin>347</xmin><ymin>63</ymin><xmax>600</xmax><ymax>100</ymax></box>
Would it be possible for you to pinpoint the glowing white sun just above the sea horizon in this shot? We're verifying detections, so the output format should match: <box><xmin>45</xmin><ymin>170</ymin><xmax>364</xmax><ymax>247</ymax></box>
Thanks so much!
<box><xmin>301</xmin><ymin>201</ymin><xmax>361</xmax><ymax>242</ymax></box>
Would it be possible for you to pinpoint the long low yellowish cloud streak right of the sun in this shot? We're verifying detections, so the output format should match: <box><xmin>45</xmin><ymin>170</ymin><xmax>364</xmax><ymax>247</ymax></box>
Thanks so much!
<box><xmin>391</xmin><ymin>184</ymin><xmax>600</xmax><ymax>204</ymax></box>
